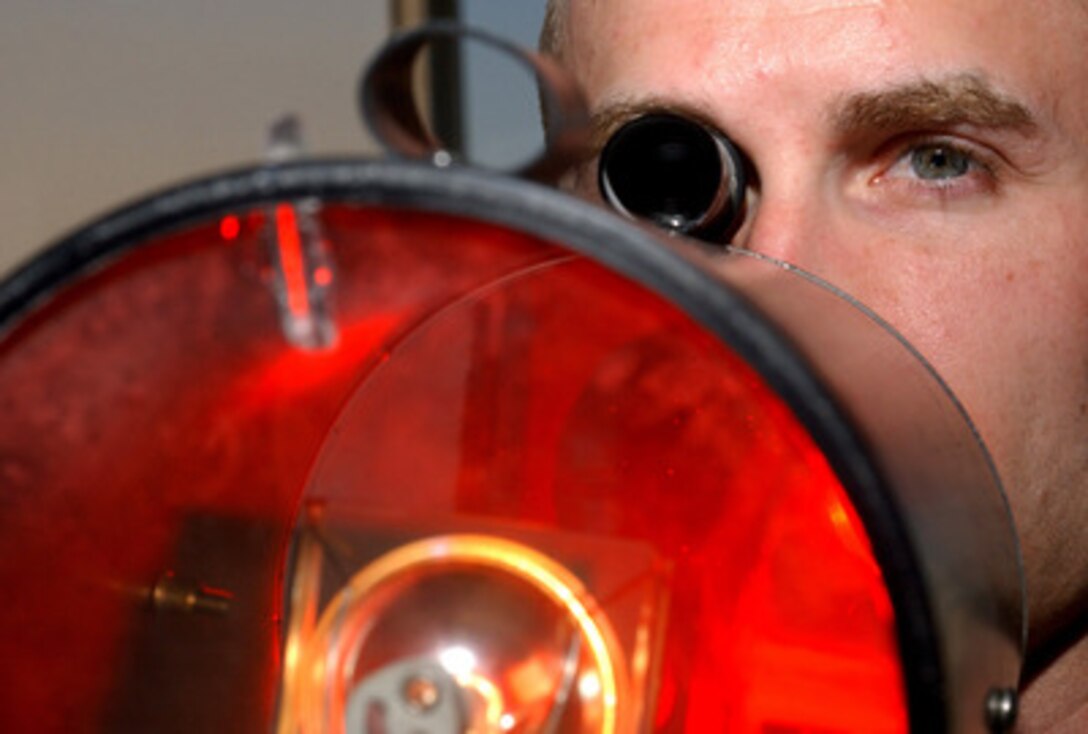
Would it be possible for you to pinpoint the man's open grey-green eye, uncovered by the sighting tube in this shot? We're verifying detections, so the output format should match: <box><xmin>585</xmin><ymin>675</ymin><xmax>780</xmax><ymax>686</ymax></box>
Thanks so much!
<box><xmin>873</xmin><ymin>137</ymin><xmax>998</xmax><ymax>201</ymax></box>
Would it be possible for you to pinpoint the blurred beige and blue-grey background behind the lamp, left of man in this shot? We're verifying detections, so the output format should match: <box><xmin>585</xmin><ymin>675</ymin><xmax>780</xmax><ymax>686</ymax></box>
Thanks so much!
<box><xmin>0</xmin><ymin>0</ymin><xmax>545</xmax><ymax>275</ymax></box>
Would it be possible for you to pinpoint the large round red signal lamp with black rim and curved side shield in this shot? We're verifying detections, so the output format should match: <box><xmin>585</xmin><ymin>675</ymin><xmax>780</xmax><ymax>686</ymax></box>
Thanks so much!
<box><xmin>0</xmin><ymin>161</ymin><xmax>1023</xmax><ymax>734</ymax></box>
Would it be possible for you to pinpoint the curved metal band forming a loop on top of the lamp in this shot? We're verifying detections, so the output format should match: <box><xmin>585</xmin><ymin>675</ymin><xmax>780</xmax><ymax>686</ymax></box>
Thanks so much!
<box><xmin>359</xmin><ymin>22</ymin><xmax>590</xmax><ymax>182</ymax></box>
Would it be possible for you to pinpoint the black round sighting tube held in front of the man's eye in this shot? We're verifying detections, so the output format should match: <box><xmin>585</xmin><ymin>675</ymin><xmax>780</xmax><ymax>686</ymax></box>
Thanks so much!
<box><xmin>598</xmin><ymin>113</ymin><xmax>746</xmax><ymax>240</ymax></box>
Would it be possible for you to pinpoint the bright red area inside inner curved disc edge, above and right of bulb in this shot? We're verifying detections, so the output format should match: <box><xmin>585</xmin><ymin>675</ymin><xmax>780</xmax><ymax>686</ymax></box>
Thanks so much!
<box><xmin>311</xmin><ymin>255</ymin><xmax>908</xmax><ymax>734</ymax></box>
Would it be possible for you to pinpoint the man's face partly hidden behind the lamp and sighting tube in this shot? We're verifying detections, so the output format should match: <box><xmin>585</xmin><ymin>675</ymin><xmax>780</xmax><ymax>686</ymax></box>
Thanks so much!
<box><xmin>559</xmin><ymin>0</ymin><xmax>1088</xmax><ymax>734</ymax></box>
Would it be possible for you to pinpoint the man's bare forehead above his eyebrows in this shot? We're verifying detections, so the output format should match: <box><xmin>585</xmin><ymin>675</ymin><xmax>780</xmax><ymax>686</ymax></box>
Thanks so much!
<box><xmin>567</xmin><ymin>0</ymin><xmax>1088</xmax><ymax>122</ymax></box>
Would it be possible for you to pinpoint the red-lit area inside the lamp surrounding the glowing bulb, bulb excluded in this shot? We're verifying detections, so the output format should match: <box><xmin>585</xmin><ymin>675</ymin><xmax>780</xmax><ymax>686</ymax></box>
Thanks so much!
<box><xmin>0</xmin><ymin>204</ymin><xmax>906</xmax><ymax>734</ymax></box>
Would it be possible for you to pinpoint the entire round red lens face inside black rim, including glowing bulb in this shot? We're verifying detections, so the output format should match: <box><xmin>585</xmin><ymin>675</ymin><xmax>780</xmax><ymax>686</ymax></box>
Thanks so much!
<box><xmin>0</xmin><ymin>204</ymin><xmax>907</xmax><ymax>734</ymax></box>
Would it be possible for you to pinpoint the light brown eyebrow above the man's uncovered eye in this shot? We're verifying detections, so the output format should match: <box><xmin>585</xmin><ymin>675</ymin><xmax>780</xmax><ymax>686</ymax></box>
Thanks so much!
<box><xmin>832</xmin><ymin>74</ymin><xmax>1039</xmax><ymax>137</ymax></box>
